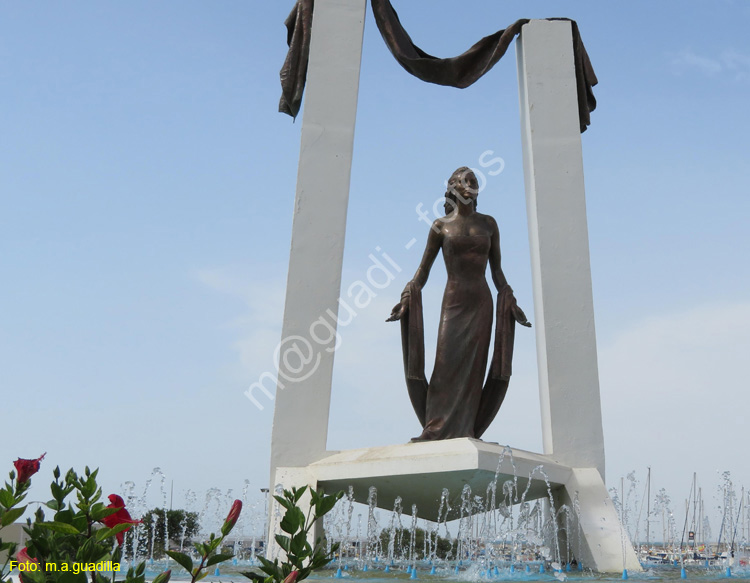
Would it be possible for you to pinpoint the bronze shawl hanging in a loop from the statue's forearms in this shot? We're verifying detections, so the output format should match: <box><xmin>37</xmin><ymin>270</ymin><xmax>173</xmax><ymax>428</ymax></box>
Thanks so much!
<box><xmin>401</xmin><ymin>282</ymin><xmax>516</xmax><ymax>439</ymax></box>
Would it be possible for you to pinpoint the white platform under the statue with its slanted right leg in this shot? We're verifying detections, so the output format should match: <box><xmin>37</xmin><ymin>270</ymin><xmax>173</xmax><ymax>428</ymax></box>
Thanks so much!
<box><xmin>270</xmin><ymin>438</ymin><xmax>641</xmax><ymax>572</ymax></box>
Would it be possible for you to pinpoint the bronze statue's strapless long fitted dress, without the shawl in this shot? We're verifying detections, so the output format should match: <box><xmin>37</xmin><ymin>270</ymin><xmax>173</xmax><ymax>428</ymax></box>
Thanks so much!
<box><xmin>418</xmin><ymin>236</ymin><xmax>493</xmax><ymax>440</ymax></box>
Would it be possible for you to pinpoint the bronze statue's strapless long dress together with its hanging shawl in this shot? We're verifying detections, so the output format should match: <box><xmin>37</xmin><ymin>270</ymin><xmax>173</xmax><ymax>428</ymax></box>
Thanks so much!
<box><xmin>401</xmin><ymin>235</ymin><xmax>515</xmax><ymax>441</ymax></box>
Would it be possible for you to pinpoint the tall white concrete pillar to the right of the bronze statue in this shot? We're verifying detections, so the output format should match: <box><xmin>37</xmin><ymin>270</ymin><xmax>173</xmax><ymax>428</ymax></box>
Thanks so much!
<box><xmin>516</xmin><ymin>20</ymin><xmax>604</xmax><ymax>479</ymax></box>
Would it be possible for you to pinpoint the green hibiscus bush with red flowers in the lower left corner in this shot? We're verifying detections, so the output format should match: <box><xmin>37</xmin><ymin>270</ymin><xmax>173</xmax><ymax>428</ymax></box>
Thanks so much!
<box><xmin>0</xmin><ymin>456</ymin><xmax>242</xmax><ymax>583</ymax></box>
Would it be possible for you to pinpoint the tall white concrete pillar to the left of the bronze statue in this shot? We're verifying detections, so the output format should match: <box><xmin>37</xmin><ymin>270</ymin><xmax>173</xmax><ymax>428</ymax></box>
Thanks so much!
<box><xmin>269</xmin><ymin>0</ymin><xmax>366</xmax><ymax>472</ymax></box>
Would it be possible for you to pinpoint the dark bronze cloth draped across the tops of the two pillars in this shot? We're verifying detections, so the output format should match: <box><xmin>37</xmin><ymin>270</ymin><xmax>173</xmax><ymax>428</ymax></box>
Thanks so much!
<box><xmin>279</xmin><ymin>0</ymin><xmax>597</xmax><ymax>132</ymax></box>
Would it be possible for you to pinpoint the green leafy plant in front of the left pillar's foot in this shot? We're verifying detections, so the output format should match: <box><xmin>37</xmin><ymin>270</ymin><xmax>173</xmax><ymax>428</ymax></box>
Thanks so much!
<box><xmin>242</xmin><ymin>487</ymin><xmax>344</xmax><ymax>583</ymax></box>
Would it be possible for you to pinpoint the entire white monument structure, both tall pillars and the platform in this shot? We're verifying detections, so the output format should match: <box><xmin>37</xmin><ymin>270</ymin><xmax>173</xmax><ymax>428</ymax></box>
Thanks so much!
<box><xmin>268</xmin><ymin>0</ymin><xmax>640</xmax><ymax>572</ymax></box>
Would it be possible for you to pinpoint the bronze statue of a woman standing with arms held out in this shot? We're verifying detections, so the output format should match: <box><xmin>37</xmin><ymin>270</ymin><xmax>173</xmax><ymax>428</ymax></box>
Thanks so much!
<box><xmin>387</xmin><ymin>167</ymin><xmax>531</xmax><ymax>441</ymax></box>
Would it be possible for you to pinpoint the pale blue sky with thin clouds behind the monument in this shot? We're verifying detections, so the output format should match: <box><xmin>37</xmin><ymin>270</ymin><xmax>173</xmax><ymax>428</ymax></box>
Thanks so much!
<box><xmin>0</xmin><ymin>0</ymin><xmax>750</xmax><ymax>528</ymax></box>
